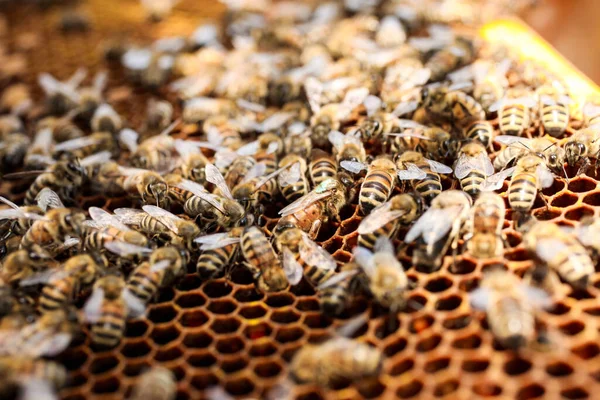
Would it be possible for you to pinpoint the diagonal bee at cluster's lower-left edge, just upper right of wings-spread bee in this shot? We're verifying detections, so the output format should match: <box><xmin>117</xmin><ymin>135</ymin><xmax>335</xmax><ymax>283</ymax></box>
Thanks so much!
<box><xmin>127</xmin><ymin>247</ymin><xmax>188</xmax><ymax>303</ymax></box>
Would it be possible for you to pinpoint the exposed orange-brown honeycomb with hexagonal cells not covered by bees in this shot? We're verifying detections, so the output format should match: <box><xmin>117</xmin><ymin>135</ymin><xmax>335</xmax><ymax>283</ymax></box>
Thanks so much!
<box><xmin>1</xmin><ymin>0</ymin><xmax>600</xmax><ymax>400</ymax></box>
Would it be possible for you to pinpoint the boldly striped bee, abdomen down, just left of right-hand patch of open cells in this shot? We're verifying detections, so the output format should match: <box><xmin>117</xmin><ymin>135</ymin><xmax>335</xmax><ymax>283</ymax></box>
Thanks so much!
<box><xmin>505</xmin><ymin>154</ymin><xmax>554</xmax><ymax>213</ymax></box>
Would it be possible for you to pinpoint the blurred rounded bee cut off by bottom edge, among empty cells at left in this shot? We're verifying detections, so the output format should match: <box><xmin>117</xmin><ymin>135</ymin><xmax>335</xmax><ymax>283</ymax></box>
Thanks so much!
<box><xmin>130</xmin><ymin>366</ymin><xmax>177</xmax><ymax>400</ymax></box>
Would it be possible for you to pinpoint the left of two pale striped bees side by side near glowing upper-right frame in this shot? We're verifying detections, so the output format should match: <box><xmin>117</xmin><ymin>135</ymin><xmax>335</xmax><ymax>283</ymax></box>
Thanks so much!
<box><xmin>489</xmin><ymin>92</ymin><xmax>535</xmax><ymax>136</ymax></box>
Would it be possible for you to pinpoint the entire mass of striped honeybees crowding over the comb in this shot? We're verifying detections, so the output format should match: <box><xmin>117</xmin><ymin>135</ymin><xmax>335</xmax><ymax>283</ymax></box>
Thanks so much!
<box><xmin>0</xmin><ymin>0</ymin><xmax>600</xmax><ymax>399</ymax></box>
